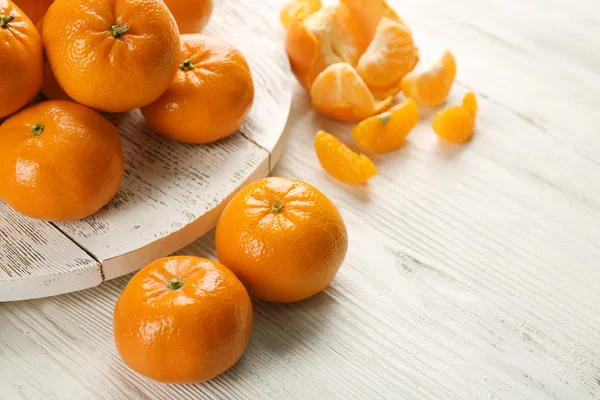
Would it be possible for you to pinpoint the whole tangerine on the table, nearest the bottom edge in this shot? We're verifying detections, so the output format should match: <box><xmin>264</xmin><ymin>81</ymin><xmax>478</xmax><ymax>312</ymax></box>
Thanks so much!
<box><xmin>113</xmin><ymin>256</ymin><xmax>252</xmax><ymax>383</ymax></box>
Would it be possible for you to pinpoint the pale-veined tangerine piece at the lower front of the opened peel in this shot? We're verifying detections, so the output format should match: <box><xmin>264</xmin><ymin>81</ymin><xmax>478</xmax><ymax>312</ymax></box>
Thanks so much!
<box><xmin>310</xmin><ymin>63</ymin><xmax>394</xmax><ymax>122</ymax></box>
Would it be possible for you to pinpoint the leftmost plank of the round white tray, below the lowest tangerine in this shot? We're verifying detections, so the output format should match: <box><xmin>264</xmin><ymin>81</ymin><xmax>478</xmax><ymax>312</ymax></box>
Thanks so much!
<box><xmin>0</xmin><ymin>202</ymin><xmax>102</xmax><ymax>302</ymax></box>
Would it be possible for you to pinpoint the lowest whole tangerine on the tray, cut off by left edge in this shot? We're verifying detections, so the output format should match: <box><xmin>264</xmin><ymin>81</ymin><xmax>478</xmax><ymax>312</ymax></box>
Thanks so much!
<box><xmin>0</xmin><ymin>101</ymin><xmax>123</xmax><ymax>221</ymax></box>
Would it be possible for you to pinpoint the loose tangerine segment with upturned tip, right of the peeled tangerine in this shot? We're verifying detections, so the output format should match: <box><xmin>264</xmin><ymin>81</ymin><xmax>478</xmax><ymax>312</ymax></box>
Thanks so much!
<box><xmin>402</xmin><ymin>50</ymin><xmax>456</xmax><ymax>107</ymax></box>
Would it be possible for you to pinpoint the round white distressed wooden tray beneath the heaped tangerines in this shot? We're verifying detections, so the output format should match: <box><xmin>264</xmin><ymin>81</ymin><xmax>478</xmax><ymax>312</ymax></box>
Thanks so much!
<box><xmin>0</xmin><ymin>1</ymin><xmax>292</xmax><ymax>302</ymax></box>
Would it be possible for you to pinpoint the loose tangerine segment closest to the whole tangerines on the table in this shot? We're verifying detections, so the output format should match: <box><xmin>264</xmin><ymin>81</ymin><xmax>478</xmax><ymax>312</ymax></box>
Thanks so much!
<box><xmin>315</xmin><ymin>131</ymin><xmax>377</xmax><ymax>183</ymax></box>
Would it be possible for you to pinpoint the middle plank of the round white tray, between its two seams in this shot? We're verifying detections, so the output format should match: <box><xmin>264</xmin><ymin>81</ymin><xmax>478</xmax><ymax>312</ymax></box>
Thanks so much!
<box><xmin>56</xmin><ymin>111</ymin><xmax>269</xmax><ymax>280</ymax></box>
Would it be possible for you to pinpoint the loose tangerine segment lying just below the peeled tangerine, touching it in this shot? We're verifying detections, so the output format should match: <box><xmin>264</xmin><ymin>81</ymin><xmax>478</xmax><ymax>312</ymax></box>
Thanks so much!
<box><xmin>352</xmin><ymin>99</ymin><xmax>419</xmax><ymax>153</ymax></box>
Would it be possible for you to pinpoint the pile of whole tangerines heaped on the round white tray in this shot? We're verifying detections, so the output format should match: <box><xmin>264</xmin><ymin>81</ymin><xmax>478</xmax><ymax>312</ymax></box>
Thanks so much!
<box><xmin>0</xmin><ymin>0</ymin><xmax>254</xmax><ymax>221</ymax></box>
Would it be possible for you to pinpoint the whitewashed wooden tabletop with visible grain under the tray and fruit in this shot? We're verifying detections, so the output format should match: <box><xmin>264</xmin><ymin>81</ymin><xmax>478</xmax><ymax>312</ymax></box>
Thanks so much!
<box><xmin>0</xmin><ymin>0</ymin><xmax>600</xmax><ymax>400</ymax></box>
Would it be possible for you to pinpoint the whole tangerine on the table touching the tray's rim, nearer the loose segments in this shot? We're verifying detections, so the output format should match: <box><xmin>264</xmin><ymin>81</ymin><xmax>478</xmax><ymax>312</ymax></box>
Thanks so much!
<box><xmin>216</xmin><ymin>178</ymin><xmax>348</xmax><ymax>302</ymax></box>
